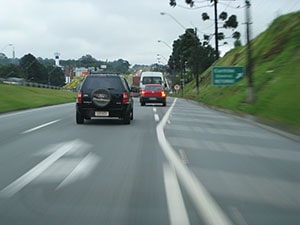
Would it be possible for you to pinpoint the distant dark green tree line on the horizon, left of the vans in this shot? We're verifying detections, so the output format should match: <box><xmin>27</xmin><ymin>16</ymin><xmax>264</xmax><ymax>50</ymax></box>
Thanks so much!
<box><xmin>0</xmin><ymin>53</ymin><xmax>130</xmax><ymax>86</ymax></box>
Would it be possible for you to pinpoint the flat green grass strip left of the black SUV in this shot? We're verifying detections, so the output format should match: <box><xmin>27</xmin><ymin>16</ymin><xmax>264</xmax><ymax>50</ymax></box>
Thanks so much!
<box><xmin>0</xmin><ymin>84</ymin><xmax>76</xmax><ymax>113</ymax></box>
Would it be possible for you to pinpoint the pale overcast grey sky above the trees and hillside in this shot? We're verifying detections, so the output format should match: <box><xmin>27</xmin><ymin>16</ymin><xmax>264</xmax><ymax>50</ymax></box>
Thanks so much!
<box><xmin>0</xmin><ymin>0</ymin><xmax>300</xmax><ymax>65</ymax></box>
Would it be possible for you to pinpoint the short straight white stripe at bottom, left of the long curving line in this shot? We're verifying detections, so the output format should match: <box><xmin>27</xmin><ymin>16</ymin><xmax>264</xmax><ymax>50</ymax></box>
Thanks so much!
<box><xmin>163</xmin><ymin>164</ymin><xmax>190</xmax><ymax>225</ymax></box>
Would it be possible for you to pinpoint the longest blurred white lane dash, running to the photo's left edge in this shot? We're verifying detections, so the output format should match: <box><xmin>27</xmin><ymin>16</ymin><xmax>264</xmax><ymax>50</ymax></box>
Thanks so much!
<box><xmin>0</xmin><ymin>140</ymin><xmax>81</xmax><ymax>197</ymax></box>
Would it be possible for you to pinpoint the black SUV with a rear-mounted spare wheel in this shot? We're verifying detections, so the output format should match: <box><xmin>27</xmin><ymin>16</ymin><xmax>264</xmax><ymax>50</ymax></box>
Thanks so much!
<box><xmin>76</xmin><ymin>74</ymin><xmax>133</xmax><ymax>124</ymax></box>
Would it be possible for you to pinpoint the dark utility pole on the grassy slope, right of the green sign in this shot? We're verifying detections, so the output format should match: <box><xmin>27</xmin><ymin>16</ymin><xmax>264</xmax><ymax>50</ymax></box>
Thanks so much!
<box><xmin>245</xmin><ymin>0</ymin><xmax>255</xmax><ymax>103</ymax></box>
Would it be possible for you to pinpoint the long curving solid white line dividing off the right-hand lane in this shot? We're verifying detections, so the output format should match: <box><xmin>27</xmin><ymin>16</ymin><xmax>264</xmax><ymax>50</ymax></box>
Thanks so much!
<box><xmin>156</xmin><ymin>98</ymin><xmax>232</xmax><ymax>225</ymax></box>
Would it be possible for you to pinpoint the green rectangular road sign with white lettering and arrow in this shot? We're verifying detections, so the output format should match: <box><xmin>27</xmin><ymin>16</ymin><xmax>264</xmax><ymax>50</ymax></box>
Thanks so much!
<box><xmin>212</xmin><ymin>66</ymin><xmax>244</xmax><ymax>86</ymax></box>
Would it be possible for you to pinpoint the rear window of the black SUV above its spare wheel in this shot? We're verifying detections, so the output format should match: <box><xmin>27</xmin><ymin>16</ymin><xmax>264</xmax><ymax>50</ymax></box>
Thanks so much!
<box><xmin>83</xmin><ymin>76</ymin><xmax>124</xmax><ymax>90</ymax></box>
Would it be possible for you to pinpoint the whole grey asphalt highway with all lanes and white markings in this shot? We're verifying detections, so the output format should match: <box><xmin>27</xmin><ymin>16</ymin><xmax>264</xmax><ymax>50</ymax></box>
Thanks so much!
<box><xmin>0</xmin><ymin>98</ymin><xmax>300</xmax><ymax>225</ymax></box>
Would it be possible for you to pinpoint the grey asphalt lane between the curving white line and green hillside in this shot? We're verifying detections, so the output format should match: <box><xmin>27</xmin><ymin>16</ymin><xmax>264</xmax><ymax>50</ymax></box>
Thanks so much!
<box><xmin>165</xmin><ymin>99</ymin><xmax>300</xmax><ymax>225</ymax></box>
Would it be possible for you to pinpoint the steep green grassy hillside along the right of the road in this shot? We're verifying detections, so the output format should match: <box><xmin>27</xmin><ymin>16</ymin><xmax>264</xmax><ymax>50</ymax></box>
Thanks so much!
<box><xmin>185</xmin><ymin>12</ymin><xmax>300</xmax><ymax>133</ymax></box>
